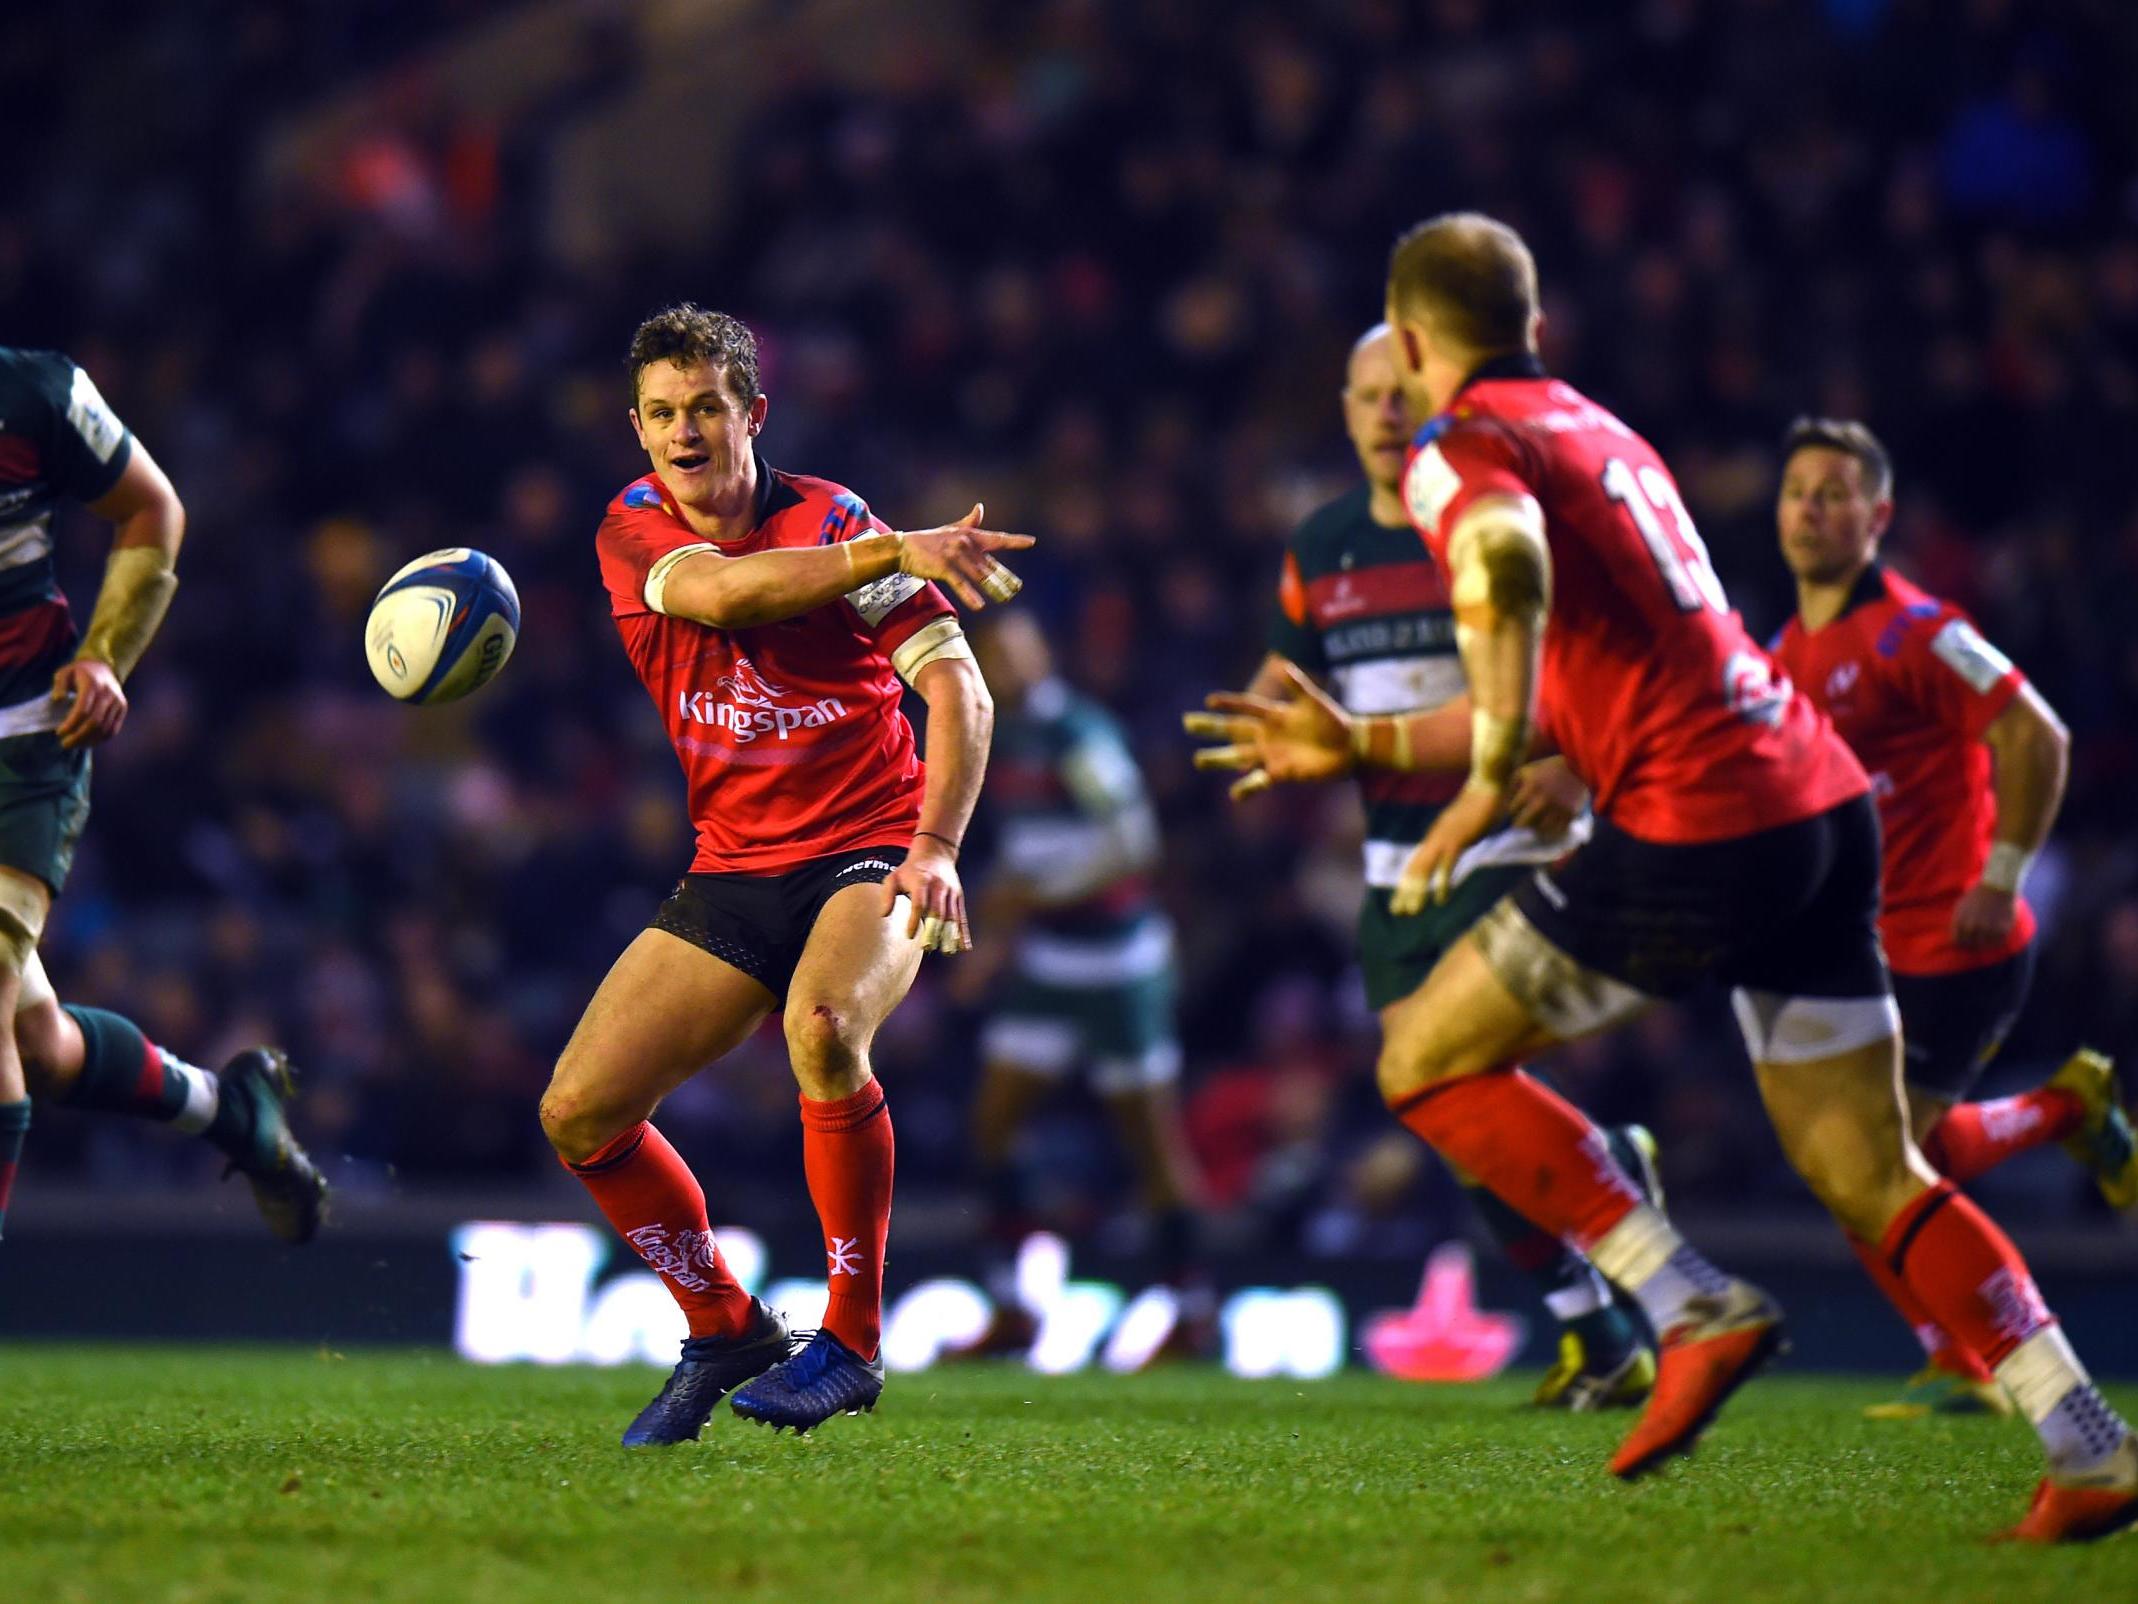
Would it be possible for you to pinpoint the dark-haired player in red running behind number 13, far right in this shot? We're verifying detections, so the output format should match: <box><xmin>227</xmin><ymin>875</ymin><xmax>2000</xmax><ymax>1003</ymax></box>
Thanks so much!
<box><xmin>1770</xmin><ymin>417</ymin><xmax>2138</xmax><ymax>1420</ymax></box>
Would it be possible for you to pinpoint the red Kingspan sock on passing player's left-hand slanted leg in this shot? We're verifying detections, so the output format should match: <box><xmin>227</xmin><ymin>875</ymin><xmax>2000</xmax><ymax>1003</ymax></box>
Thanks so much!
<box><xmin>564</xmin><ymin>1121</ymin><xmax>750</xmax><ymax>1337</ymax></box>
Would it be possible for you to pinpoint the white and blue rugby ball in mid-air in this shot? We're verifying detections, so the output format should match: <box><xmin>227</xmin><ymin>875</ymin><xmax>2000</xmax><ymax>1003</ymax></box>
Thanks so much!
<box><xmin>363</xmin><ymin>545</ymin><xmax>520</xmax><ymax>706</ymax></box>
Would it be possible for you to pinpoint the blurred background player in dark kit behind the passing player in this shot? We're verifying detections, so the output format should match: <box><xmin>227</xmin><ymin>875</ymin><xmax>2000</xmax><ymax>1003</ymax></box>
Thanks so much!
<box><xmin>951</xmin><ymin>612</ymin><xmax>1219</xmax><ymax>1358</ymax></box>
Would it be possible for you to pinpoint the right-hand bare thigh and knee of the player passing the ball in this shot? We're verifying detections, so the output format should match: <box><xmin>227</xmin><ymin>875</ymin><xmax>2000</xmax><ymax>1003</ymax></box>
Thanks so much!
<box><xmin>787</xmin><ymin>885</ymin><xmax>921</xmax><ymax>1101</ymax></box>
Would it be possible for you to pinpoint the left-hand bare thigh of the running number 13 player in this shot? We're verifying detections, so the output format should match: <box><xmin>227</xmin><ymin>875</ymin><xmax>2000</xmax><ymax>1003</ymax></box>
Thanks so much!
<box><xmin>1379</xmin><ymin>898</ymin><xmax>1646</xmax><ymax>1104</ymax></box>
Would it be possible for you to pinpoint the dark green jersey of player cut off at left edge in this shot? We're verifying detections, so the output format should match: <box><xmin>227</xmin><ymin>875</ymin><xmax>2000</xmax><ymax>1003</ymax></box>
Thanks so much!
<box><xmin>0</xmin><ymin>346</ymin><xmax>133</xmax><ymax>723</ymax></box>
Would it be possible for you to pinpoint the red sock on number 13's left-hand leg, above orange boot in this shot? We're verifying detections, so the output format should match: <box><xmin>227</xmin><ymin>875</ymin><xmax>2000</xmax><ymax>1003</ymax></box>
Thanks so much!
<box><xmin>1390</xmin><ymin>1069</ymin><xmax>1640</xmax><ymax>1251</ymax></box>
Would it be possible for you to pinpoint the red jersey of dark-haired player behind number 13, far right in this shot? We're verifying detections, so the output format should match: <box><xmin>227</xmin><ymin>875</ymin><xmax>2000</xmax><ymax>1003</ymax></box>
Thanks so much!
<box><xmin>1775</xmin><ymin>562</ymin><xmax>2033</xmax><ymax>975</ymax></box>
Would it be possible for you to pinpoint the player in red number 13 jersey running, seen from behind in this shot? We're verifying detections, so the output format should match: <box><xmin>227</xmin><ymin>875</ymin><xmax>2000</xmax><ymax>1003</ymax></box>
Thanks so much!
<box><xmin>1199</xmin><ymin>214</ymin><xmax>2138</xmax><ymax>1542</ymax></box>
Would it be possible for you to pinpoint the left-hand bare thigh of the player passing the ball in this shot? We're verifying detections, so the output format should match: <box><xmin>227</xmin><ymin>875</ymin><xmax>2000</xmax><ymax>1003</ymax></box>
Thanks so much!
<box><xmin>541</xmin><ymin>930</ymin><xmax>776</xmax><ymax>1161</ymax></box>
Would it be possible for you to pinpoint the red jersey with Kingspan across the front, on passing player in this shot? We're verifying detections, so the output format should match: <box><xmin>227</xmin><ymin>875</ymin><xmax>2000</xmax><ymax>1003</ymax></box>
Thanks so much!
<box><xmin>594</xmin><ymin>458</ymin><xmax>951</xmax><ymax>875</ymax></box>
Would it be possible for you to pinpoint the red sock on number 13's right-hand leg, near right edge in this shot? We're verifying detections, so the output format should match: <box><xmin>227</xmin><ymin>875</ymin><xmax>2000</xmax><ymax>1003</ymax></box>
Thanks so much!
<box><xmin>1879</xmin><ymin>1181</ymin><xmax>2055</xmax><ymax>1367</ymax></box>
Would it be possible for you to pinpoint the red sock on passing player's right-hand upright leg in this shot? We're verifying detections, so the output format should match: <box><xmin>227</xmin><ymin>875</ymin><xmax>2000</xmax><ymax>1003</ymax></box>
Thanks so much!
<box><xmin>802</xmin><ymin>1078</ymin><xmax>894</xmax><ymax>1358</ymax></box>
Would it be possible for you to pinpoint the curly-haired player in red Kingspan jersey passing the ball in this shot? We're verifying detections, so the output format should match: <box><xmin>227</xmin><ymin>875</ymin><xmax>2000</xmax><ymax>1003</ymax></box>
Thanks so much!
<box><xmin>541</xmin><ymin>304</ymin><xmax>1031</xmax><ymax>1446</ymax></box>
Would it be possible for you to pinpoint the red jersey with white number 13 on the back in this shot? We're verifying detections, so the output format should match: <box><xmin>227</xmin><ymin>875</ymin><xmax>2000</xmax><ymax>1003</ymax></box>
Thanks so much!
<box><xmin>1403</xmin><ymin>357</ymin><xmax>1869</xmax><ymax>843</ymax></box>
